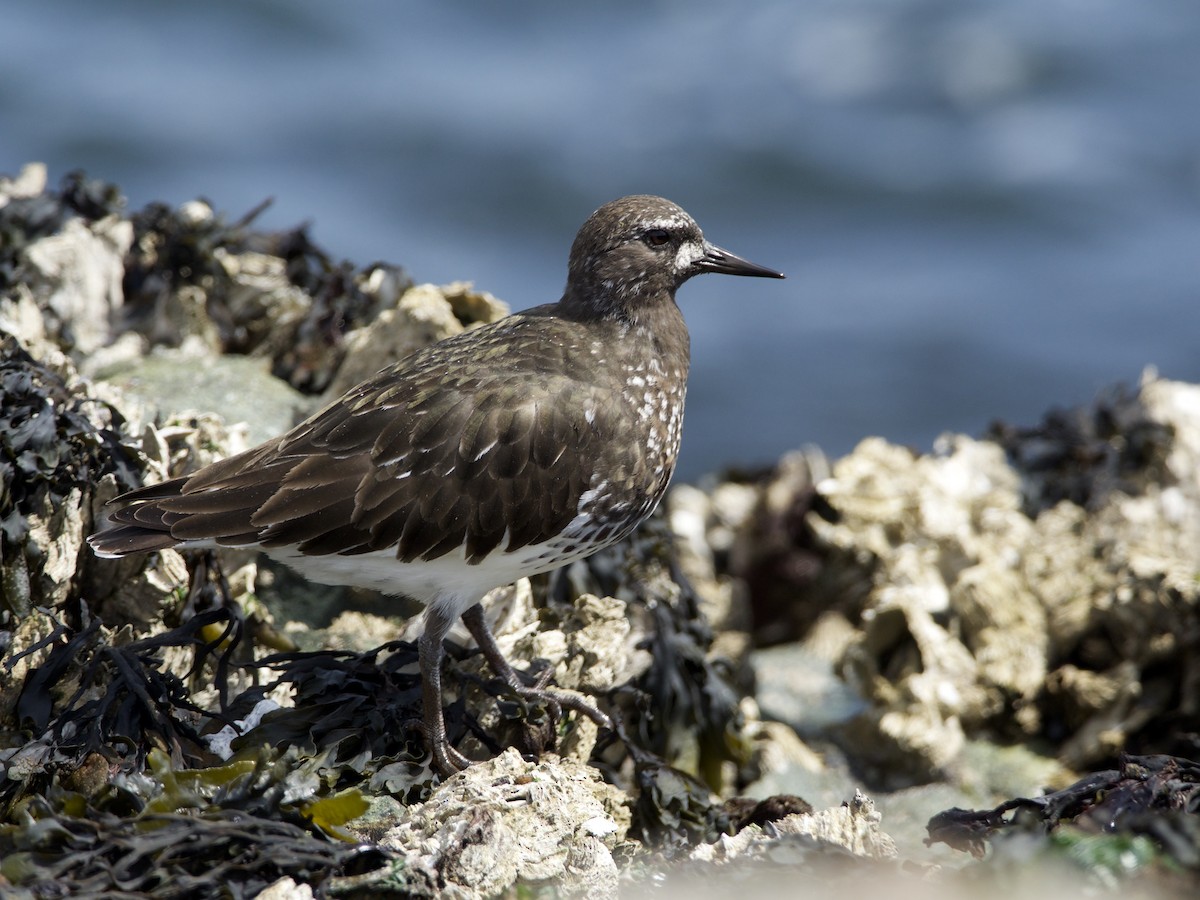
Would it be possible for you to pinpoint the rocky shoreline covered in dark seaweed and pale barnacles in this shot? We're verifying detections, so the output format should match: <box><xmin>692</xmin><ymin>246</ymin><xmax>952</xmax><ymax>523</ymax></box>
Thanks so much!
<box><xmin>0</xmin><ymin>166</ymin><xmax>1200</xmax><ymax>898</ymax></box>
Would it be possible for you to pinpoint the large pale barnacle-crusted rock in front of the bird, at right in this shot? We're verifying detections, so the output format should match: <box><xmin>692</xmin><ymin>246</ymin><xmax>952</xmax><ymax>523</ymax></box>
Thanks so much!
<box><xmin>724</xmin><ymin>376</ymin><xmax>1200</xmax><ymax>786</ymax></box>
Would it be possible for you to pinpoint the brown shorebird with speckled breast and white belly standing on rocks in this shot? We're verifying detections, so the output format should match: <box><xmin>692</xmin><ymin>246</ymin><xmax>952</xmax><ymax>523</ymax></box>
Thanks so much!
<box><xmin>89</xmin><ymin>194</ymin><xmax>785</xmax><ymax>776</ymax></box>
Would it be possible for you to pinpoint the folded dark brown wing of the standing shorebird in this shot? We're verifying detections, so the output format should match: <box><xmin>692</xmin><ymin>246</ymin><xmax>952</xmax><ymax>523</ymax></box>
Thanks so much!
<box><xmin>94</xmin><ymin>321</ymin><xmax>614</xmax><ymax>562</ymax></box>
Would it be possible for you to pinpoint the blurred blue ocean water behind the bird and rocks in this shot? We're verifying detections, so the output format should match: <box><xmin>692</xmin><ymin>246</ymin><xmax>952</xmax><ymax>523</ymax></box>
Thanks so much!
<box><xmin>0</xmin><ymin>0</ymin><xmax>1200</xmax><ymax>479</ymax></box>
